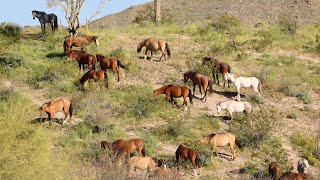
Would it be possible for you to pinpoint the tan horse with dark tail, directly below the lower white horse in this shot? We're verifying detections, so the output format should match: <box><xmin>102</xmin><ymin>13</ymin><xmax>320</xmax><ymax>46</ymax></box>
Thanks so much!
<box><xmin>199</xmin><ymin>133</ymin><xmax>241</xmax><ymax>160</ymax></box>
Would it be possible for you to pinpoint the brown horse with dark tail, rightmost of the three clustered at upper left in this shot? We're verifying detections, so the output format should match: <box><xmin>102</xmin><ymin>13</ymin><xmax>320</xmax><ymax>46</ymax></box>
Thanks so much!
<box><xmin>96</xmin><ymin>54</ymin><xmax>127</xmax><ymax>81</ymax></box>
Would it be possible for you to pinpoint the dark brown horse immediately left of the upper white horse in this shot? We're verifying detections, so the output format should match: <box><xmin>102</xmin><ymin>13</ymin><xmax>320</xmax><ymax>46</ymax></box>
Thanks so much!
<box><xmin>202</xmin><ymin>57</ymin><xmax>231</xmax><ymax>87</ymax></box>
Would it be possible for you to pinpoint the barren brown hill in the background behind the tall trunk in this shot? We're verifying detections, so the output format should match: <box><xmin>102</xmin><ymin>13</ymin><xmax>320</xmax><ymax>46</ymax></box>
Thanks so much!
<box><xmin>92</xmin><ymin>0</ymin><xmax>320</xmax><ymax>28</ymax></box>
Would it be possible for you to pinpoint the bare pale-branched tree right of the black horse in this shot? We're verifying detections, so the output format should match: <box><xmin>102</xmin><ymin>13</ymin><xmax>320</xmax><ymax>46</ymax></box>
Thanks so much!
<box><xmin>46</xmin><ymin>0</ymin><xmax>109</xmax><ymax>36</ymax></box>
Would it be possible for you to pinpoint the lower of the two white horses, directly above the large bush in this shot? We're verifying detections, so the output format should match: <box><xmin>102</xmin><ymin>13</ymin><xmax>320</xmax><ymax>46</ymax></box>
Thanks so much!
<box><xmin>217</xmin><ymin>100</ymin><xmax>252</xmax><ymax>120</ymax></box>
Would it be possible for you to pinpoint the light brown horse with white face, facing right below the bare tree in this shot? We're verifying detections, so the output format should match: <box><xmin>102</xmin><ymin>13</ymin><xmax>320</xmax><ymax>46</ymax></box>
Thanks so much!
<box><xmin>63</xmin><ymin>35</ymin><xmax>99</xmax><ymax>54</ymax></box>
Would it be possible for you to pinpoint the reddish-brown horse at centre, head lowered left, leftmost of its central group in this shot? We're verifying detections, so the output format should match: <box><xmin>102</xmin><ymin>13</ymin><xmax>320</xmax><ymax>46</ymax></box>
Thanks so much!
<box><xmin>153</xmin><ymin>84</ymin><xmax>193</xmax><ymax>109</ymax></box>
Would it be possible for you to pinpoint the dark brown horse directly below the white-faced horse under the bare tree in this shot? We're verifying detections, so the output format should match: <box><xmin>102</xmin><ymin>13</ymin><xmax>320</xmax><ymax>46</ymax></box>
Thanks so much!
<box><xmin>68</xmin><ymin>50</ymin><xmax>96</xmax><ymax>71</ymax></box>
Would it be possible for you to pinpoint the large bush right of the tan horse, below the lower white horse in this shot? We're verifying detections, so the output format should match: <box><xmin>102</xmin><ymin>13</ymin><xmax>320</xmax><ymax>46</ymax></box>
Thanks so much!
<box><xmin>230</xmin><ymin>108</ymin><xmax>278</xmax><ymax>148</ymax></box>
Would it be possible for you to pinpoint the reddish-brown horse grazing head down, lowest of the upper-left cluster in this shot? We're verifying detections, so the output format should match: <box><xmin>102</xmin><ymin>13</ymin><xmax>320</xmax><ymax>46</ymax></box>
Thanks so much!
<box><xmin>80</xmin><ymin>69</ymin><xmax>109</xmax><ymax>90</ymax></box>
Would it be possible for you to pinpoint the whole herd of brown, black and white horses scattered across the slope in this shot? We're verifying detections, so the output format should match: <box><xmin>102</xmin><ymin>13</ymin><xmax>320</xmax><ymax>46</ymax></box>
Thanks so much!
<box><xmin>32</xmin><ymin>11</ymin><xmax>306</xmax><ymax>179</ymax></box>
